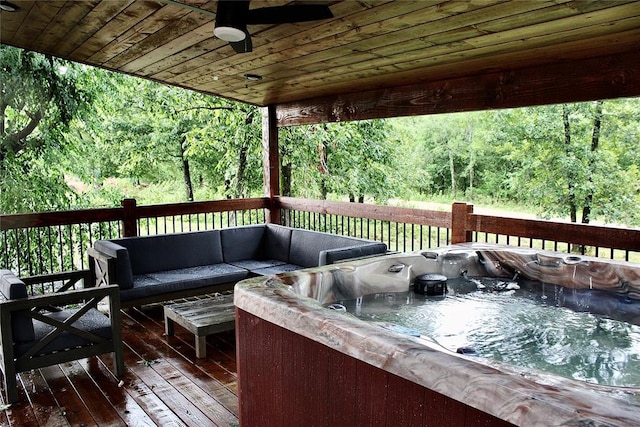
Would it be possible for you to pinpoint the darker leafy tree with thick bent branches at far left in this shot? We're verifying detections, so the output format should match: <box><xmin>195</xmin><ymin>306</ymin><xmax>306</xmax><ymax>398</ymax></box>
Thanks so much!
<box><xmin>0</xmin><ymin>45</ymin><xmax>91</xmax><ymax>213</ymax></box>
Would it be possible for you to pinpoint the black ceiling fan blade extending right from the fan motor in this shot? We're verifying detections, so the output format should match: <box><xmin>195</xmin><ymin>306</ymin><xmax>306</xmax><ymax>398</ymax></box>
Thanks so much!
<box><xmin>246</xmin><ymin>4</ymin><xmax>333</xmax><ymax>24</ymax></box>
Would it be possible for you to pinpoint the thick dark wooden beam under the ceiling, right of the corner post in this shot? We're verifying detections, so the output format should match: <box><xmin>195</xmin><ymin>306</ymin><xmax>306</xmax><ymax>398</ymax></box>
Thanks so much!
<box><xmin>276</xmin><ymin>51</ymin><xmax>640</xmax><ymax>127</ymax></box>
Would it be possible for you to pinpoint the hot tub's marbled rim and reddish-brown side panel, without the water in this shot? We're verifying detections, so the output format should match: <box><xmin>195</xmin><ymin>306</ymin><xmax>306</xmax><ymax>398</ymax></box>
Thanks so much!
<box><xmin>235</xmin><ymin>244</ymin><xmax>640</xmax><ymax>426</ymax></box>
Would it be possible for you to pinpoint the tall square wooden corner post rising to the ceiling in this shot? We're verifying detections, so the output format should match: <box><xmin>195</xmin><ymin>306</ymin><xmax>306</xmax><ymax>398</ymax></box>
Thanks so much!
<box><xmin>262</xmin><ymin>105</ymin><xmax>280</xmax><ymax>224</ymax></box>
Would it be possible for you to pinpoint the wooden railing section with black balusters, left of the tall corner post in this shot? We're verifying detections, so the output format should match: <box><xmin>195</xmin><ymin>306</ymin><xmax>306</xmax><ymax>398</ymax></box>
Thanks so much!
<box><xmin>0</xmin><ymin>198</ymin><xmax>269</xmax><ymax>277</ymax></box>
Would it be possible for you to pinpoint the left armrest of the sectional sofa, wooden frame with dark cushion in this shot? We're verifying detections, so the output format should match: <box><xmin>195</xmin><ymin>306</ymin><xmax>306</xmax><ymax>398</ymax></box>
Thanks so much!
<box><xmin>88</xmin><ymin>240</ymin><xmax>133</xmax><ymax>289</ymax></box>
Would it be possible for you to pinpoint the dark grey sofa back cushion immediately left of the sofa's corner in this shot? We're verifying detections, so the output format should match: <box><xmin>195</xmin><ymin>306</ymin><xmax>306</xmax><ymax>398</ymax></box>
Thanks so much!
<box><xmin>220</xmin><ymin>225</ymin><xmax>266</xmax><ymax>262</ymax></box>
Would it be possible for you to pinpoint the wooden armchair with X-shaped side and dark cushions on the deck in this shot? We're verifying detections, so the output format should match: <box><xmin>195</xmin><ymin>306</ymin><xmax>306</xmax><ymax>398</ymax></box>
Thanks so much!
<box><xmin>0</xmin><ymin>270</ymin><xmax>124</xmax><ymax>403</ymax></box>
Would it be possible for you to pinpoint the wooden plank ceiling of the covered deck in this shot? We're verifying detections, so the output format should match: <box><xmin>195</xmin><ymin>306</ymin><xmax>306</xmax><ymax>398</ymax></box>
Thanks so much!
<box><xmin>0</xmin><ymin>0</ymin><xmax>640</xmax><ymax>106</ymax></box>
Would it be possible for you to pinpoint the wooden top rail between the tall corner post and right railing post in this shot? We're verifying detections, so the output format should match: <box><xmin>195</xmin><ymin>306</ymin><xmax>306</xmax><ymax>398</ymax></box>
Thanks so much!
<box><xmin>275</xmin><ymin>197</ymin><xmax>451</xmax><ymax>228</ymax></box>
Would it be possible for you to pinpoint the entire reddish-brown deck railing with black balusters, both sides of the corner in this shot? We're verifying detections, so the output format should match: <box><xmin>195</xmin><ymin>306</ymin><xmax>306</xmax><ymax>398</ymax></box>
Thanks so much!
<box><xmin>0</xmin><ymin>197</ymin><xmax>640</xmax><ymax>277</ymax></box>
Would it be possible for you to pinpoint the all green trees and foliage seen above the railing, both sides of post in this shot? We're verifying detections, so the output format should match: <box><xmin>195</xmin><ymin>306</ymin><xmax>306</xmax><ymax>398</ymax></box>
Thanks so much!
<box><xmin>0</xmin><ymin>46</ymin><xmax>640</xmax><ymax>229</ymax></box>
